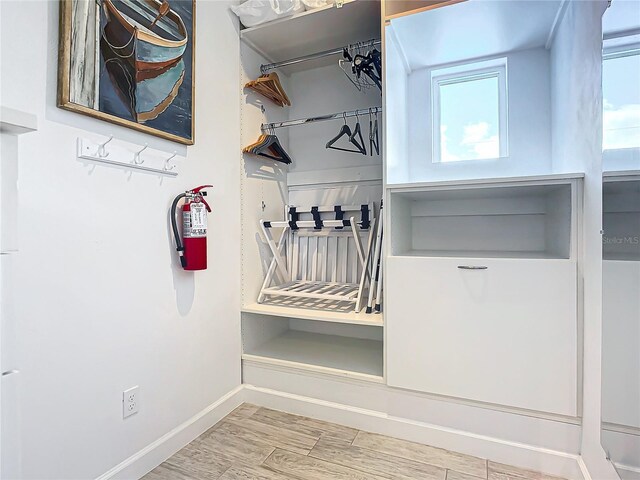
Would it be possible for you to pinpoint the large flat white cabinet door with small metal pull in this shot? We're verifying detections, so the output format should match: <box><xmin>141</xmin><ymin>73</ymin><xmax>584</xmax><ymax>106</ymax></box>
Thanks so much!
<box><xmin>385</xmin><ymin>257</ymin><xmax>578</xmax><ymax>416</ymax></box>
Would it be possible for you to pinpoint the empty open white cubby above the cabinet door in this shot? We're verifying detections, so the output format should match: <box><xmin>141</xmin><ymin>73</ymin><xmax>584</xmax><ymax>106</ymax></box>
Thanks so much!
<box><xmin>389</xmin><ymin>179</ymin><xmax>577</xmax><ymax>259</ymax></box>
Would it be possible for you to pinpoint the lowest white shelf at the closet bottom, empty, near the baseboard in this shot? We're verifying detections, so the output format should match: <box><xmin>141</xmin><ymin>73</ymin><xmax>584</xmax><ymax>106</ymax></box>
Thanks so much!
<box><xmin>242</xmin><ymin>330</ymin><xmax>383</xmax><ymax>382</ymax></box>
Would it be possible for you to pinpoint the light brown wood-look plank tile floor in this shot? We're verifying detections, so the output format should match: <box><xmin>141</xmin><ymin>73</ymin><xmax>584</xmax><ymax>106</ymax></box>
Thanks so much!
<box><xmin>144</xmin><ymin>403</ymin><xmax>560</xmax><ymax>480</ymax></box>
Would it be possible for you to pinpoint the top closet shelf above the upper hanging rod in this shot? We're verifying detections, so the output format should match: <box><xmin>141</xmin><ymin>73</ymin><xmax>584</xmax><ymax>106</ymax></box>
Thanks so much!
<box><xmin>240</xmin><ymin>0</ymin><xmax>381</xmax><ymax>73</ymax></box>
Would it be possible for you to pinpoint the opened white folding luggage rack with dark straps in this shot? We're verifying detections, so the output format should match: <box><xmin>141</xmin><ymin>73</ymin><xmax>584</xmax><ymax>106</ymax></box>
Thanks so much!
<box><xmin>258</xmin><ymin>204</ymin><xmax>376</xmax><ymax>312</ymax></box>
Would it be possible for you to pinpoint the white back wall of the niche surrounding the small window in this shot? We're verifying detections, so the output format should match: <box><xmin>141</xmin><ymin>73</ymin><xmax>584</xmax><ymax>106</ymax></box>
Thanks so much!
<box><xmin>407</xmin><ymin>48</ymin><xmax>551</xmax><ymax>182</ymax></box>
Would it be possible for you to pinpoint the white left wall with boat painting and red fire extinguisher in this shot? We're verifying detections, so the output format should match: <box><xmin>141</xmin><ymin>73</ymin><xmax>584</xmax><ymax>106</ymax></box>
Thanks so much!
<box><xmin>0</xmin><ymin>0</ymin><xmax>241</xmax><ymax>480</ymax></box>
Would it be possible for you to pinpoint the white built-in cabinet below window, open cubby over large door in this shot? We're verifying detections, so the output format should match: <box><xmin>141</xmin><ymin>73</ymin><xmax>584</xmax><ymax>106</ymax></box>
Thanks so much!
<box><xmin>386</xmin><ymin>175</ymin><xmax>581</xmax><ymax>417</ymax></box>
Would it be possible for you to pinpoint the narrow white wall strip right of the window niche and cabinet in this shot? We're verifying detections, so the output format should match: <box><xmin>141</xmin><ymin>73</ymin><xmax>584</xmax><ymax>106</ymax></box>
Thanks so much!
<box><xmin>551</xmin><ymin>1</ymin><xmax>617</xmax><ymax>480</ymax></box>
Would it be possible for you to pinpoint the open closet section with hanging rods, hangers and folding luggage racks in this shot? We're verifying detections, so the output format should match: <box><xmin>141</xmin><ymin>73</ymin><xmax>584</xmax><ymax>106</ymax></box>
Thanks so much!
<box><xmin>240</xmin><ymin>0</ymin><xmax>384</xmax><ymax>382</ymax></box>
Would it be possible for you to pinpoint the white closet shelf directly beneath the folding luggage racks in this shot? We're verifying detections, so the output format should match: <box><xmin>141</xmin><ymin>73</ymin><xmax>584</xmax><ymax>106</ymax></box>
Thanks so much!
<box><xmin>242</xmin><ymin>299</ymin><xmax>384</xmax><ymax>327</ymax></box>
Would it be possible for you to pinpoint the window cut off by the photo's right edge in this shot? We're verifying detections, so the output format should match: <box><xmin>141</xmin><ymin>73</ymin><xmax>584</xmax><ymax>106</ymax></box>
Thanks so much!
<box><xmin>602</xmin><ymin>45</ymin><xmax>640</xmax><ymax>150</ymax></box>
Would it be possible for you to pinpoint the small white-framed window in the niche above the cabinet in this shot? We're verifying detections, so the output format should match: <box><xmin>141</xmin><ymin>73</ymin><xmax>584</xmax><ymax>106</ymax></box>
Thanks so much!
<box><xmin>431</xmin><ymin>58</ymin><xmax>508</xmax><ymax>163</ymax></box>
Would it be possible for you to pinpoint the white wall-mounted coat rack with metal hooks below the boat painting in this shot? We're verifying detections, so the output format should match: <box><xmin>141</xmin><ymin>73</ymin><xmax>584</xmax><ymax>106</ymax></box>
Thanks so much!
<box><xmin>78</xmin><ymin>135</ymin><xmax>184</xmax><ymax>177</ymax></box>
